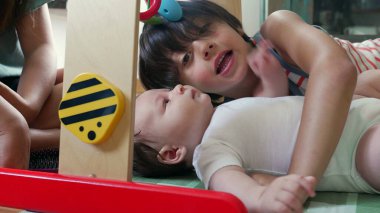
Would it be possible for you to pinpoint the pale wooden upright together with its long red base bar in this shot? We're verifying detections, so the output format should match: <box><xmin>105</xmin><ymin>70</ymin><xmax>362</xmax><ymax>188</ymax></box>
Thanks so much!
<box><xmin>0</xmin><ymin>0</ymin><xmax>246</xmax><ymax>213</ymax></box>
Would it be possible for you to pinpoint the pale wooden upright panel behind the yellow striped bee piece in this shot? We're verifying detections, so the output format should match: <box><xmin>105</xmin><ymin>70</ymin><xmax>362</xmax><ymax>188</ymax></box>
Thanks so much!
<box><xmin>59</xmin><ymin>0</ymin><xmax>140</xmax><ymax>181</ymax></box>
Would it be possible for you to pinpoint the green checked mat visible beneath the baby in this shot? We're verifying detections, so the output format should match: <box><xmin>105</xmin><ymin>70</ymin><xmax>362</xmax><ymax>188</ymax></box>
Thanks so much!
<box><xmin>133</xmin><ymin>173</ymin><xmax>380</xmax><ymax>213</ymax></box>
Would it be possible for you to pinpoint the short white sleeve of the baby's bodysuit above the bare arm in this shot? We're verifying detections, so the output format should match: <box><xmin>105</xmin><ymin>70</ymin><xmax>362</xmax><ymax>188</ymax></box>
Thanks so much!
<box><xmin>193</xmin><ymin>140</ymin><xmax>242</xmax><ymax>189</ymax></box>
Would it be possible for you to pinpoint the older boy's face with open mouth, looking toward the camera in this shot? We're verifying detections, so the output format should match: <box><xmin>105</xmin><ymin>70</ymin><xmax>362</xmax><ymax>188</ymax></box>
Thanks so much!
<box><xmin>172</xmin><ymin>23</ymin><xmax>255</xmax><ymax>95</ymax></box>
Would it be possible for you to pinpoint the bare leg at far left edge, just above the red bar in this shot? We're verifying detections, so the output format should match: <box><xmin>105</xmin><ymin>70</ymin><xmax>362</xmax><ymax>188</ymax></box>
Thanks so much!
<box><xmin>0</xmin><ymin>96</ymin><xmax>30</xmax><ymax>169</ymax></box>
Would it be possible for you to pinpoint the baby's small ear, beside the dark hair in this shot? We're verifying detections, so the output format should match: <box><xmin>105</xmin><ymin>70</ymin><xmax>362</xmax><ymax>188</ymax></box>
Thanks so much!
<box><xmin>157</xmin><ymin>145</ymin><xmax>187</xmax><ymax>164</ymax></box>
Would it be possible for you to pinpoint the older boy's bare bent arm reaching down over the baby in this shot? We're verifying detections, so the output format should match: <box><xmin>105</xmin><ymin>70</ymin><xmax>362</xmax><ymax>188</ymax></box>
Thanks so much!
<box><xmin>261</xmin><ymin>11</ymin><xmax>357</xmax><ymax>179</ymax></box>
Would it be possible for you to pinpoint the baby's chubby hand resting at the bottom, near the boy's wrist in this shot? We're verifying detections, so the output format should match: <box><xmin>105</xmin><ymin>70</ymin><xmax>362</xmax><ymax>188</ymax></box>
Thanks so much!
<box><xmin>257</xmin><ymin>174</ymin><xmax>317</xmax><ymax>212</ymax></box>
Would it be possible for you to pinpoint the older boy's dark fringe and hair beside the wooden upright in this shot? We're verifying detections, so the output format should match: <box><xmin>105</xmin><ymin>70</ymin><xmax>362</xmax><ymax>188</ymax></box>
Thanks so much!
<box><xmin>139</xmin><ymin>0</ymin><xmax>247</xmax><ymax>89</ymax></box>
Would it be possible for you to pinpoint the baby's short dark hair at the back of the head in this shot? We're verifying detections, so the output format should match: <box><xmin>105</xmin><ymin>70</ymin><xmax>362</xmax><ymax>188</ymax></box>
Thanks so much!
<box><xmin>133</xmin><ymin>135</ymin><xmax>192</xmax><ymax>178</ymax></box>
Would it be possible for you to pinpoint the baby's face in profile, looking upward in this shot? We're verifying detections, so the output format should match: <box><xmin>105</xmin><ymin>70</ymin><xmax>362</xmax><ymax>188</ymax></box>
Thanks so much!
<box><xmin>135</xmin><ymin>85</ymin><xmax>214</xmax><ymax>154</ymax></box>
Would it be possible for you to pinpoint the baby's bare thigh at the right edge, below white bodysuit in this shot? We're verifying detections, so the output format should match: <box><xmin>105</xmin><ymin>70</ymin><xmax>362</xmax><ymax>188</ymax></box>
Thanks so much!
<box><xmin>355</xmin><ymin>124</ymin><xmax>380</xmax><ymax>190</ymax></box>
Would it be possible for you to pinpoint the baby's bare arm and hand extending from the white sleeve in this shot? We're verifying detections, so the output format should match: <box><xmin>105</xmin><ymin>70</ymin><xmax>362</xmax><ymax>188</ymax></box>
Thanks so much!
<box><xmin>209</xmin><ymin>166</ymin><xmax>316</xmax><ymax>212</ymax></box>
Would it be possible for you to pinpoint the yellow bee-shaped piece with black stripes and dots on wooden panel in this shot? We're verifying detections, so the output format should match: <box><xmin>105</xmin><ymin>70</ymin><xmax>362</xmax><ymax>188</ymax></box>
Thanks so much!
<box><xmin>58</xmin><ymin>73</ymin><xmax>124</xmax><ymax>144</ymax></box>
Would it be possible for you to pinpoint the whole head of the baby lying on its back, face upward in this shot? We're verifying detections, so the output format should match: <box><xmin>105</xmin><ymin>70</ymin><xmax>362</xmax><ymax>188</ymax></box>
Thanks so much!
<box><xmin>133</xmin><ymin>85</ymin><xmax>214</xmax><ymax>177</ymax></box>
